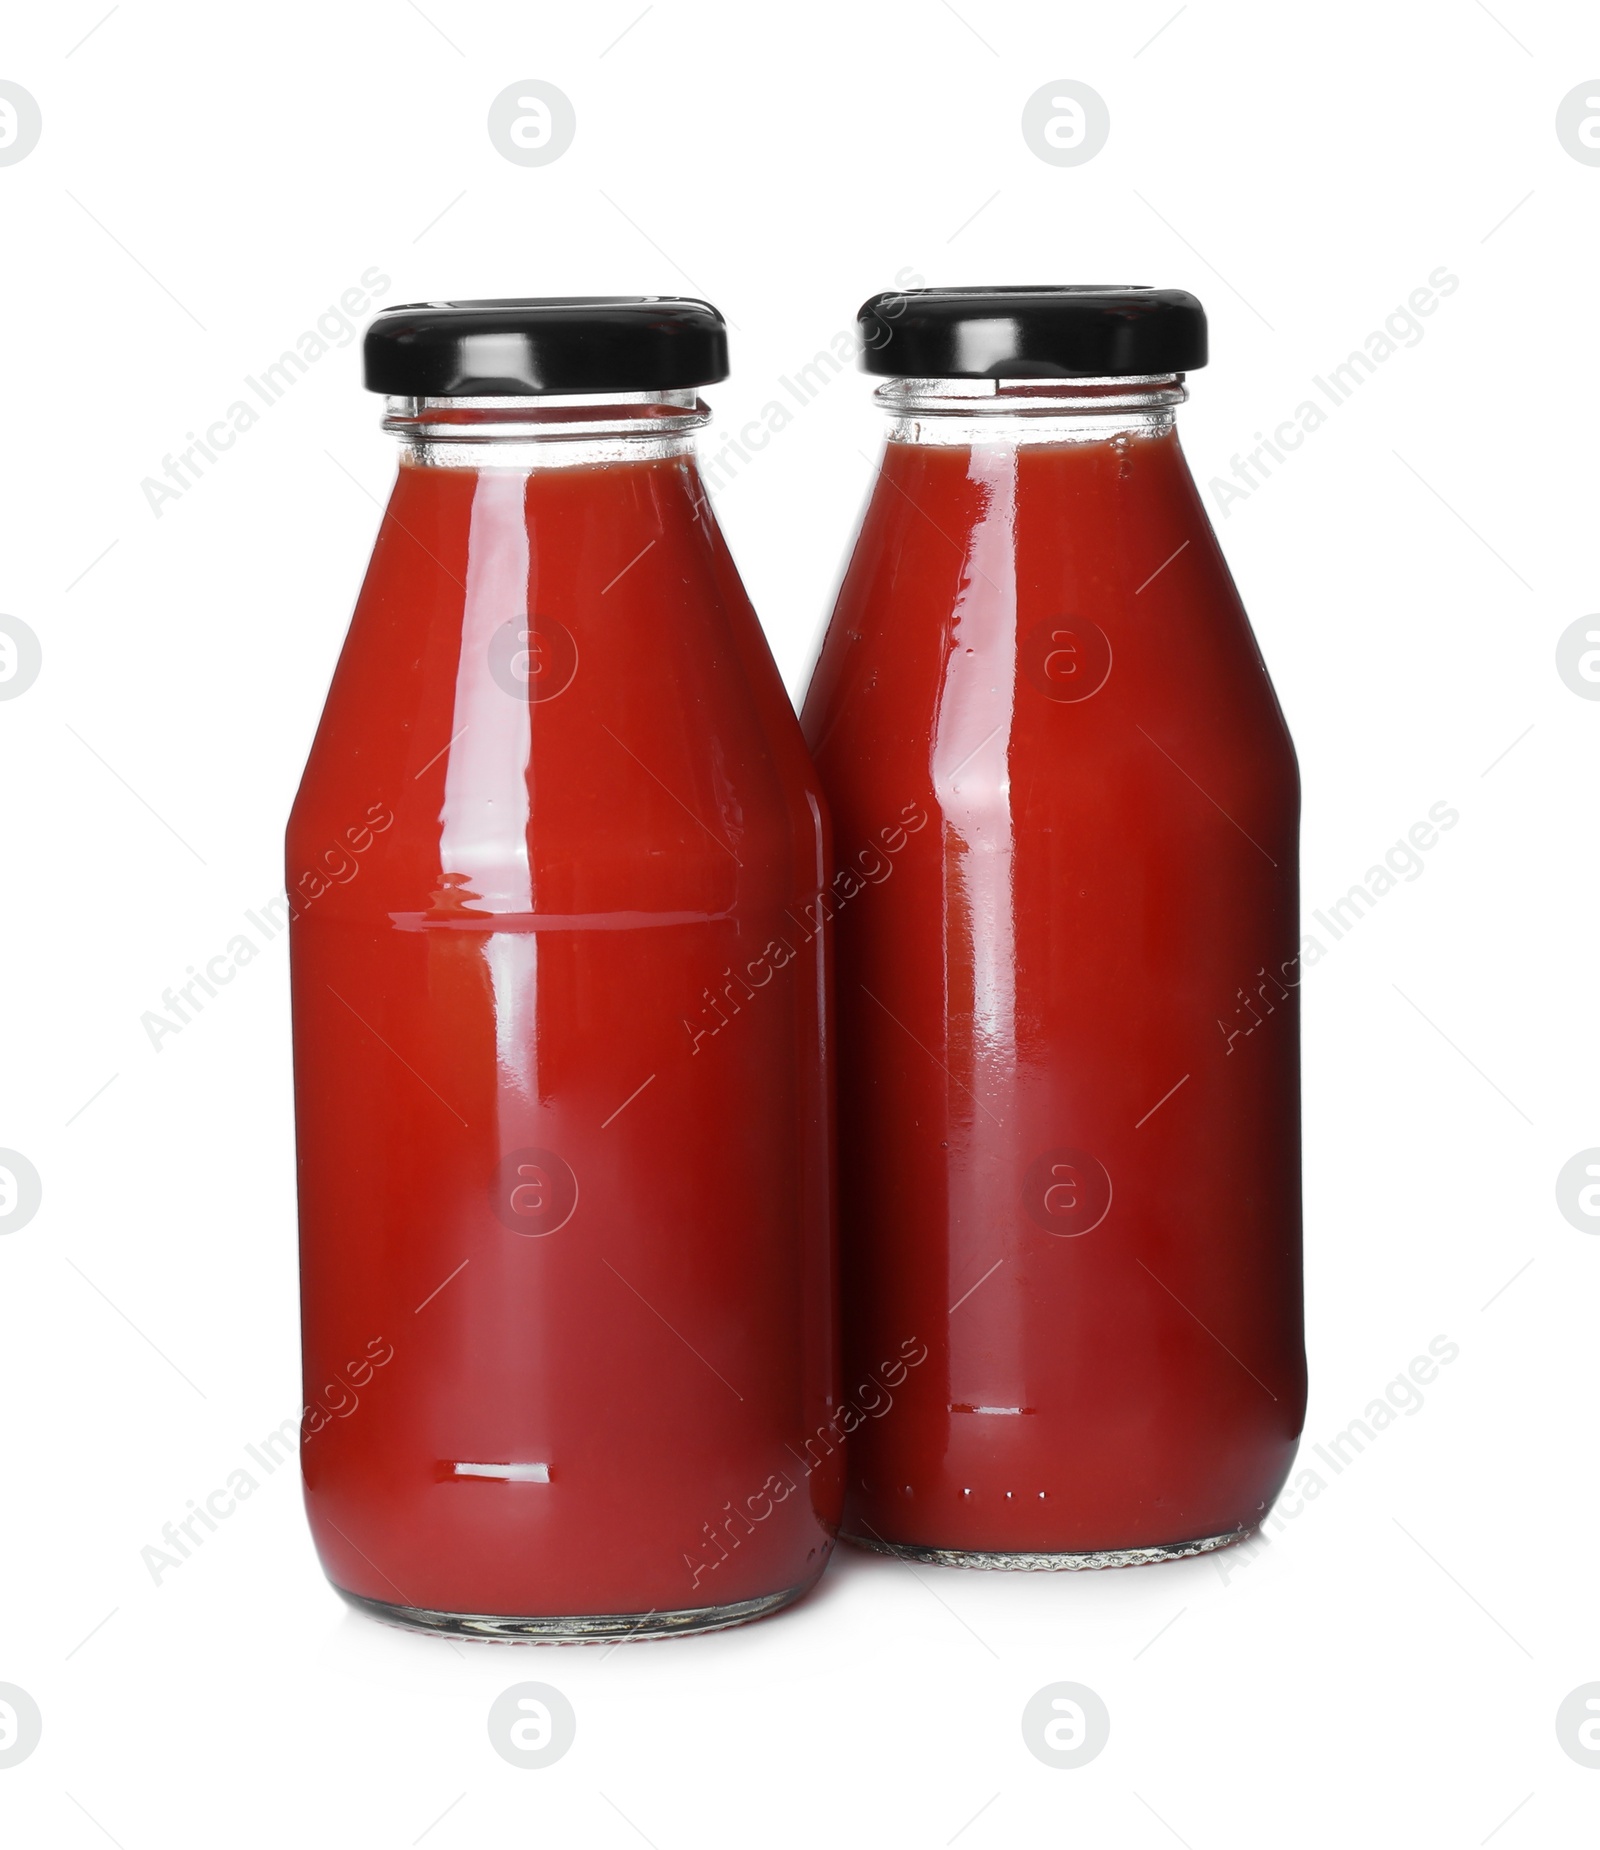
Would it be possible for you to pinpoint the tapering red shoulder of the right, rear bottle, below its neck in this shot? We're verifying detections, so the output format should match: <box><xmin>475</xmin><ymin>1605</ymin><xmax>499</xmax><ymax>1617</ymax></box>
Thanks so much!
<box><xmin>803</xmin><ymin>437</ymin><xmax>1282</xmax><ymax>755</ymax></box>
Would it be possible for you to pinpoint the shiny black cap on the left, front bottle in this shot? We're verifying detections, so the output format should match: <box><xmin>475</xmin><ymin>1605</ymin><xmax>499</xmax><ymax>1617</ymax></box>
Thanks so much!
<box><xmin>363</xmin><ymin>296</ymin><xmax>727</xmax><ymax>398</ymax></box>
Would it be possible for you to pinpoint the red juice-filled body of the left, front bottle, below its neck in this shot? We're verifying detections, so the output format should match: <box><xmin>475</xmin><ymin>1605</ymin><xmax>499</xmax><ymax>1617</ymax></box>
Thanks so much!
<box><xmin>289</xmin><ymin>401</ymin><xmax>840</xmax><ymax>1635</ymax></box>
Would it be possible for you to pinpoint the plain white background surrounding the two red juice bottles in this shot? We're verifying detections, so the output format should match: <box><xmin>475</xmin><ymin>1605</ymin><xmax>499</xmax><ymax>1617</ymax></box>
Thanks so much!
<box><xmin>0</xmin><ymin>0</ymin><xmax>1600</xmax><ymax>1850</ymax></box>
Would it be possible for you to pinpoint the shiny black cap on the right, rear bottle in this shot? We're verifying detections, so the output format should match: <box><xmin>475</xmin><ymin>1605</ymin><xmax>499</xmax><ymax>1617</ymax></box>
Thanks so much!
<box><xmin>856</xmin><ymin>283</ymin><xmax>1206</xmax><ymax>379</ymax></box>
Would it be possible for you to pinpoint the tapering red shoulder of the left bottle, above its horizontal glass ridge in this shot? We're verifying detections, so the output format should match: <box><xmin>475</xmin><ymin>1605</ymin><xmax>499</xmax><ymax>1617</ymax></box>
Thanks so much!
<box><xmin>289</xmin><ymin>451</ymin><xmax>825</xmax><ymax>910</ymax></box>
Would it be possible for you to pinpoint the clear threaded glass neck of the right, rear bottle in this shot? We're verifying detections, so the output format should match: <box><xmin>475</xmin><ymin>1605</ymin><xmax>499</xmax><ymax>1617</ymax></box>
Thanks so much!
<box><xmin>873</xmin><ymin>372</ymin><xmax>1189</xmax><ymax>450</ymax></box>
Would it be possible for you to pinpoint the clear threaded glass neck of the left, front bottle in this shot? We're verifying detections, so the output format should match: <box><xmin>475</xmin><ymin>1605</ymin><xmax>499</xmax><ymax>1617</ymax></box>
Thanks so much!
<box><xmin>383</xmin><ymin>390</ymin><xmax>710</xmax><ymax>472</ymax></box>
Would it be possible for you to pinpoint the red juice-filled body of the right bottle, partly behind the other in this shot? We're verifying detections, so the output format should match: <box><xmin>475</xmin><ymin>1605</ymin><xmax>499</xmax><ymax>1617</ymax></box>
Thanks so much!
<box><xmin>803</xmin><ymin>381</ymin><xmax>1304</xmax><ymax>1565</ymax></box>
